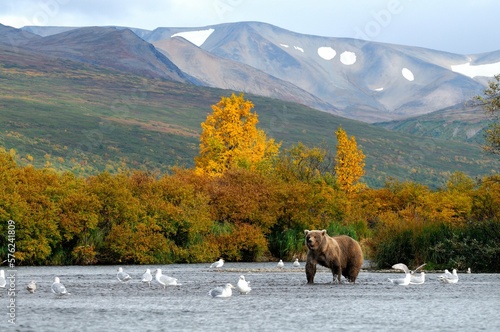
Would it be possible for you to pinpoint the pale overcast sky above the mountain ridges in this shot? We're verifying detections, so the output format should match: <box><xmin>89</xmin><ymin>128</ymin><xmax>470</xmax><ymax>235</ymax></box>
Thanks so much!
<box><xmin>0</xmin><ymin>0</ymin><xmax>500</xmax><ymax>54</ymax></box>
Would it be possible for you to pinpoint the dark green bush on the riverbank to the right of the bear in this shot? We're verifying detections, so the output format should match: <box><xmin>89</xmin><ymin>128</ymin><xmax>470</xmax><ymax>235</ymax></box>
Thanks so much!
<box><xmin>374</xmin><ymin>221</ymin><xmax>500</xmax><ymax>272</ymax></box>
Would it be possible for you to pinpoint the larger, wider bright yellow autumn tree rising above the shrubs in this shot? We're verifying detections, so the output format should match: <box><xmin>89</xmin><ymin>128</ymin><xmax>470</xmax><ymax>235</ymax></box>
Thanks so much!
<box><xmin>195</xmin><ymin>94</ymin><xmax>281</xmax><ymax>176</ymax></box>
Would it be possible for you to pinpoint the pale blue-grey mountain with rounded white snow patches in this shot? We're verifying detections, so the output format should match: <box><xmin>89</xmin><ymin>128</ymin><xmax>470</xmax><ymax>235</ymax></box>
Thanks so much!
<box><xmin>144</xmin><ymin>22</ymin><xmax>500</xmax><ymax>122</ymax></box>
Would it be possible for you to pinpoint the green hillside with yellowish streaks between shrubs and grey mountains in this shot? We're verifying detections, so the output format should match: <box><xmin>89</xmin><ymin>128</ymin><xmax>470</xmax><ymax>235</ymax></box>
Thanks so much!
<box><xmin>0</xmin><ymin>49</ymin><xmax>500</xmax><ymax>187</ymax></box>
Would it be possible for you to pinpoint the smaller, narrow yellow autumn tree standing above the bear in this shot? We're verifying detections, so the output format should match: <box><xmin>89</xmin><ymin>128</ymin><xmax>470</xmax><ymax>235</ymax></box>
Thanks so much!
<box><xmin>335</xmin><ymin>127</ymin><xmax>365</xmax><ymax>194</ymax></box>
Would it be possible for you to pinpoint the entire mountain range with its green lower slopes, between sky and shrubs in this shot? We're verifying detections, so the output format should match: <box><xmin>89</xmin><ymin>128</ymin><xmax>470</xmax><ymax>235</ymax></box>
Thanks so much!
<box><xmin>0</xmin><ymin>22</ymin><xmax>500</xmax><ymax>185</ymax></box>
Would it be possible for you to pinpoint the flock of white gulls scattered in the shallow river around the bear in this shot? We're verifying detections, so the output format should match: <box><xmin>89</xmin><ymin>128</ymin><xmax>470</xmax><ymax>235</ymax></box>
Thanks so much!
<box><xmin>0</xmin><ymin>258</ymin><xmax>471</xmax><ymax>298</ymax></box>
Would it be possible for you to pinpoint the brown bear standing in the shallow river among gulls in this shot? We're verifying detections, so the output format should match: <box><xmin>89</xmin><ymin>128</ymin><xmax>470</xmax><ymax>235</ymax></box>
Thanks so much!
<box><xmin>304</xmin><ymin>229</ymin><xmax>363</xmax><ymax>284</ymax></box>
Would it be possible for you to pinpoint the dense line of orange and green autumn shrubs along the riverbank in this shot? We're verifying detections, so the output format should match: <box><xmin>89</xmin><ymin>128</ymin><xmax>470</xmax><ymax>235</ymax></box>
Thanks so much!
<box><xmin>0</xmin><ymin>151</ymin><xmax>500</xmax><ymax>272</ymax></box>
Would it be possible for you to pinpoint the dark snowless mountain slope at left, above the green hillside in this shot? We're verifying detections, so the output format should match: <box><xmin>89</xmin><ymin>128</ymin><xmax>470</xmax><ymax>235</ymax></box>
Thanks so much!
<box><xmin>4</xmin><ymin>26</ymin><xmax>190</xmax><ymax>83</ymax></box>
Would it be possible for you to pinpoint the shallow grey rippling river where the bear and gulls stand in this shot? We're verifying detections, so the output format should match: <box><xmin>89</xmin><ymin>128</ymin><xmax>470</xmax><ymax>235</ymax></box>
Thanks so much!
<box><xmin>0</xmin><ymin>263</ymin><xmax>500</xmax><ymax>332</ymax></box>
